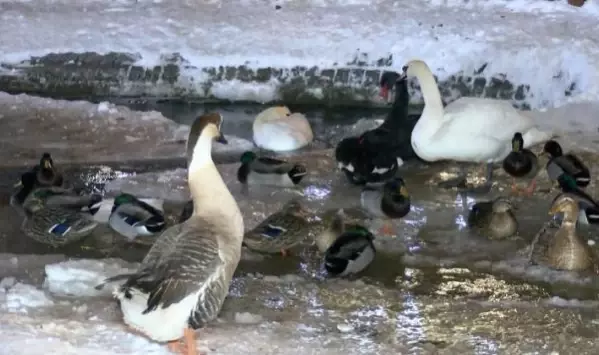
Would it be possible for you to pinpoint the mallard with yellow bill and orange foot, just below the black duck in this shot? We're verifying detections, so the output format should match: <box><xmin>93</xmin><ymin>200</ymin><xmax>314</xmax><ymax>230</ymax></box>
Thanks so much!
<box><xmin>360</xmin><ymin>178</ymin><xmax>411</xmax><ymax>235</ymax></box>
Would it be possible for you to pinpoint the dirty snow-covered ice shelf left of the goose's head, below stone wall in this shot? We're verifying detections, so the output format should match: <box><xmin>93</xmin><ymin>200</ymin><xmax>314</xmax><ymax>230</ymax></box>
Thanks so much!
<box><xmin>0</xmin><ymin>92</ymin><xmax>253</xmax><ymax>166</ymax></box>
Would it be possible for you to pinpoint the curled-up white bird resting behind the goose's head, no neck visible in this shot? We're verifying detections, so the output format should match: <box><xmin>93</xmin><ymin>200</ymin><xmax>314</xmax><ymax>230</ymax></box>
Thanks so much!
<box><xmin>253</xmin><ymin>106</ymin><xmax>314</xmax><ymax>152</ymax></box>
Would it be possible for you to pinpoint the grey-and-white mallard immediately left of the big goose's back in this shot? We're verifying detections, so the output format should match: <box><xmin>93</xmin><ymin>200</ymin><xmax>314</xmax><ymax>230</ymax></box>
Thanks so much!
<box><xmin>108</xmin><ymin>193</ymin><xmax>166</xmax><ymax>240</ymax></box>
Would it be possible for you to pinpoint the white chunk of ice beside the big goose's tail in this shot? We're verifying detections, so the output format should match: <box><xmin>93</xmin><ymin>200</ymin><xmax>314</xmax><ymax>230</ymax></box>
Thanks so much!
<box><xmin>44</xmin><ymin>259</ymin><xmax>135</xmax><ymax>297</ymax></box>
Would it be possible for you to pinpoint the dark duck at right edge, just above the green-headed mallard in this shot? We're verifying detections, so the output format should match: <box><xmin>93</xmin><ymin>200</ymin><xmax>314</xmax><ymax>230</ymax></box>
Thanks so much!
<box><xmin>543</xmin><ymin>140</ymin><xmax>591</xmax><ymax>187</ymax></box>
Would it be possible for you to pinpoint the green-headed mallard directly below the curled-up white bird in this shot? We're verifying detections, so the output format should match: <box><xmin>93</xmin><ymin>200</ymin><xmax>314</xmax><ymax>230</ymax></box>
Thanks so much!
<box><xmin>237</xmin><ymin>151</ymin><xmax>308</xmax><ymax>187</ymax></box>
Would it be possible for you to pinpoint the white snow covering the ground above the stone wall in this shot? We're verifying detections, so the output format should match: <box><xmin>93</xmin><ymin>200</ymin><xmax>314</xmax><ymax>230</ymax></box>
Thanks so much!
<box><xmin>0</xmin><ymin>0</ymin><xmax>599</xmax><ymax>107</ymax></box>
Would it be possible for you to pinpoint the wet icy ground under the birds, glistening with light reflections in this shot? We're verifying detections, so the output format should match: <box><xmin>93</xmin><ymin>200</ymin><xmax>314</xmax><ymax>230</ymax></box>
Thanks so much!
<box><xmin>0</xmin><ymin>93</ymin><xmax>599</xmax><ymax>354</ymax></box>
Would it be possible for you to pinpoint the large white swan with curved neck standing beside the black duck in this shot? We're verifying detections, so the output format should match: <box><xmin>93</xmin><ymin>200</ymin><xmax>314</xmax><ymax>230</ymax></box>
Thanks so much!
<box><xmin>403</xmin><ymin>60</ymin><xmax>553</xmax><ymax>191</ymax></box>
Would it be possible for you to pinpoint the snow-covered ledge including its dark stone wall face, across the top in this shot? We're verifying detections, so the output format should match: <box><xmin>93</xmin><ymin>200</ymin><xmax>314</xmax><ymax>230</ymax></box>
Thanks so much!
<box><xmin>0</xmin><ymin>0</ymin><xmax>599</xmax><ymax>108</ymax></box>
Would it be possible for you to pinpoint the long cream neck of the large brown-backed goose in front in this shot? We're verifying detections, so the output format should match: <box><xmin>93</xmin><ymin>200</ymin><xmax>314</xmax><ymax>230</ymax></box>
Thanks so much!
<box><xmin>187</xmin><ymin>135</ymin><xmax>243</xmax><ymax>238</ymax></box>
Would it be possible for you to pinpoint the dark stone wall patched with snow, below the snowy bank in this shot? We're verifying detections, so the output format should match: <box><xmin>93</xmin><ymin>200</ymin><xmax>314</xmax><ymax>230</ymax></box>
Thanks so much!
<box><xmin>0</xmin><ymin>53</ymin><xmax>575</xmax><ymax>108</ymax></box>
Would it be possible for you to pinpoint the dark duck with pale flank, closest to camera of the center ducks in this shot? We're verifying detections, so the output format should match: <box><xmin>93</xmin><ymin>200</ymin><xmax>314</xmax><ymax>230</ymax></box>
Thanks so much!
<box><xmin>324</xmin><ymin>225</ymin><xmax>376</xmax><ymax>276</ymax></box>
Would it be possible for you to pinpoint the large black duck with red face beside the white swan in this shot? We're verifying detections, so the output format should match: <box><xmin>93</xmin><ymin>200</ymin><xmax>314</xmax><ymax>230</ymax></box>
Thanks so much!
<box><xmin>335</xmin><ymin>72</ymin><xmax>417</xmax><ymax>185</ymax></box>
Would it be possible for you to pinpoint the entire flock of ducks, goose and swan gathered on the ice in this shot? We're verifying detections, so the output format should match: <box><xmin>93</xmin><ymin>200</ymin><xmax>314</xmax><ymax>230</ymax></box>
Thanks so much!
<box><xmin>10</xmin><ymin>60</ymin><xmax>599</xmax><ymax>355</ymax></box>
